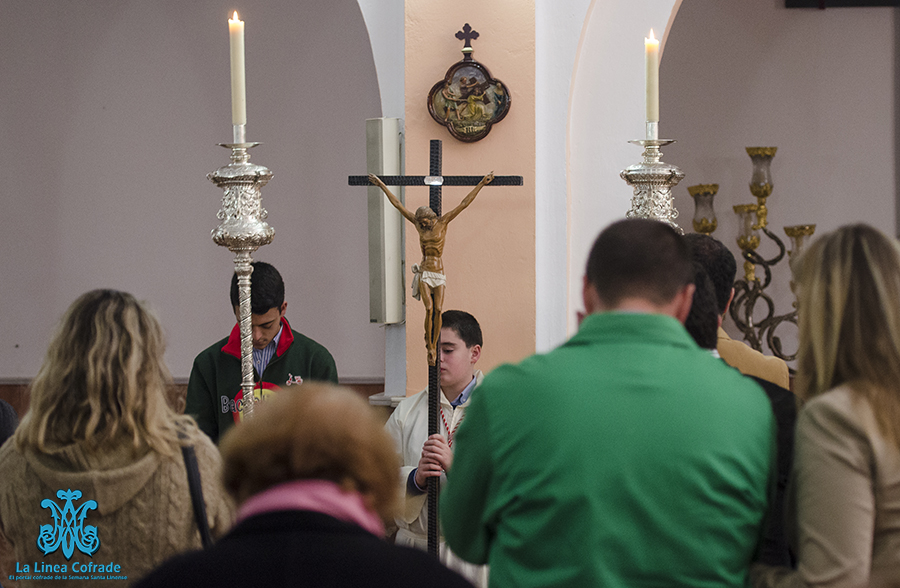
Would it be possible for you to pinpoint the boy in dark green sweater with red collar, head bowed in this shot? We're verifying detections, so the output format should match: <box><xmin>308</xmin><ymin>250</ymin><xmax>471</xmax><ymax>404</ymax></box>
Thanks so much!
<box><xmin>185</xmin><ymin>261</ymin><xmax>338</xmax><ymax>443</ymax></box>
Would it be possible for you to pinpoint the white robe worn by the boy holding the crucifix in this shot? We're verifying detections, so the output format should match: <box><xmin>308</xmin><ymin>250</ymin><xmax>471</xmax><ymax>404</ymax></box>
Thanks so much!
<box><xmin>385</xmin><ymin>370</ymin><xmax>488</xmax><ymax>588</ymax></box>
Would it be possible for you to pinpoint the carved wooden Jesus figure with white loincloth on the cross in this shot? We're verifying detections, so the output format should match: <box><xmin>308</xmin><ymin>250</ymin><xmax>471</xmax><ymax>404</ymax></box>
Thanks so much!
<box><xmin>369</xmin><ymin>172</ymin><xmax>494</xmax><ymax>365</ymax></box>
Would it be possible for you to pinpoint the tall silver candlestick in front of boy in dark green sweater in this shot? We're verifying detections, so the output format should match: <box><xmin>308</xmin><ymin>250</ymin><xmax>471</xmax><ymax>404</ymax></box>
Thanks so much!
<box><xmin>206</xmin><ymin>125</ymin><xmax>275</xmax><ymax>417</ymax></box>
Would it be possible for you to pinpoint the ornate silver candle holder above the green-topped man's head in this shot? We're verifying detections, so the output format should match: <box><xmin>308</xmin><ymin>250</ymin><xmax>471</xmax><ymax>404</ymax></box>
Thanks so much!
<box><xmin>619</xmin><ymin>138</ymin><xmax>684</xmax><ymax>233</ymax></box>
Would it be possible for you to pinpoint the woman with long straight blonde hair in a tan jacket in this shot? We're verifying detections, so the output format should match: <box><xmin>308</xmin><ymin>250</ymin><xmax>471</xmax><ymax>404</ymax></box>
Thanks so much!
<box><xmin>753</xmin><ymin>225</ymin><xmax>900</xmax><ymax>587</ymax></box>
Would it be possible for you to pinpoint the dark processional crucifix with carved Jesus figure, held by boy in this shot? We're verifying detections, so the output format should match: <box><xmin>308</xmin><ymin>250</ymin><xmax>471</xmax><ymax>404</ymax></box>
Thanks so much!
<box><xmin>349</xmin><ymin>139</ymin><xmax>522</xmax><ymax>556</ymax></box>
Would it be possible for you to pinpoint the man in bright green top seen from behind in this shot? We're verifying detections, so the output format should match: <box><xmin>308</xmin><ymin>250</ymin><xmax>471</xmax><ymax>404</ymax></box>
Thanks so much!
<box><xmin>441</xmin><ymin>219</ymin><xmax>774</xmax><ymax>588</ymax></box>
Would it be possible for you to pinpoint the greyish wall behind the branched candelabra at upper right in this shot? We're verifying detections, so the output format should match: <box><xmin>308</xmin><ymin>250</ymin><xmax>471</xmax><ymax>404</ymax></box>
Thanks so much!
<box><xmin>660</xmin><ymin>0</ymin><xmax>898</xmax><ymax>360</ymax></box>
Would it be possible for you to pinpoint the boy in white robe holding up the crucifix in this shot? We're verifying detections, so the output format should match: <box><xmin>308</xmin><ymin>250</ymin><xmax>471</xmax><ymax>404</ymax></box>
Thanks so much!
<box><xmin>385</xmin><ymin>310</ymin><xmax>488</xmax><ymax>588</ymax></box>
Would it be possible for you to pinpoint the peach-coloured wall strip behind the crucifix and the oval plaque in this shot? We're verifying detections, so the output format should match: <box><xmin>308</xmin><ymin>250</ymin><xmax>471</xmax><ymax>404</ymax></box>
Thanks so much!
<box><xmin>405</xmin><ymin>0</ymin><xmax>535</xmax><ymax>394</ymax></box>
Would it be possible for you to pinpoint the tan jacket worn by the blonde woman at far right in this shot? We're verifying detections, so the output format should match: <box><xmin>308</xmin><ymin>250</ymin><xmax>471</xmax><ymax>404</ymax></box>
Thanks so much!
<box><xmin>751</xmin><ymin>386</ymin><xmax>900</xmax><ymax>588</ymax></box>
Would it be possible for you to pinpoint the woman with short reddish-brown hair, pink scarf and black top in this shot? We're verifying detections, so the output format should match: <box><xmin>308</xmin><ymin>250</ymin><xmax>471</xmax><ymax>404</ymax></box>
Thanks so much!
<box><xmin>137</xmin><ymin>382</ymin><xmax>470</xmax><ymax>588</ymax></box>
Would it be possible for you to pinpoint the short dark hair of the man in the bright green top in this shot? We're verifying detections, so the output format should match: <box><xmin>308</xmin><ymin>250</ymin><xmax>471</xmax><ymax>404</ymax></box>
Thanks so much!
<box><xmin>586</xmin><ymin>219</ymin><xmax>693</xmax><ymax>306</ymax></box>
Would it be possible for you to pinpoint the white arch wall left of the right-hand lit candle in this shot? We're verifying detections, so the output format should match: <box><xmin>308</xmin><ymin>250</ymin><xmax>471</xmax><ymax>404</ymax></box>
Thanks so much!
<box><xmin>567</xmin><ymin>0</ymin><xmax>690</xmax><ymax>330</ymax></box>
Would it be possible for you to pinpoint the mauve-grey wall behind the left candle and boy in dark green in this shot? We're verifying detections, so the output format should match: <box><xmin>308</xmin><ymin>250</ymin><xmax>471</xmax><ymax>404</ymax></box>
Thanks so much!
<box><xmin>0</xmin><ymin>0</ymin><xmax>384</xmax><ymax>380</ymax></box>
